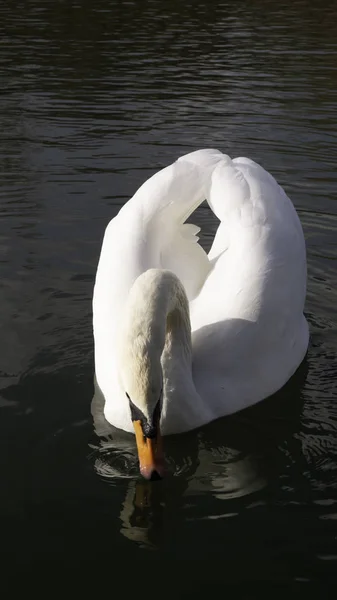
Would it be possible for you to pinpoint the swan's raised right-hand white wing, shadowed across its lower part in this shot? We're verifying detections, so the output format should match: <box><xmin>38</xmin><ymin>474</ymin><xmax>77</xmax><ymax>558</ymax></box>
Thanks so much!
<box><xmin>191</xmin><ymin>156</ymin><xmax>308</xmax><ymax>416</ymax></box>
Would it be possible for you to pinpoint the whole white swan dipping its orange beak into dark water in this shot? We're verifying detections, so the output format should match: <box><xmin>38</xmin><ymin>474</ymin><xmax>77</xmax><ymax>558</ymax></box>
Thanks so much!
<box><xmin>93</xmin><ymin>149</ymin><xmax>309</xmax><ymax>479</ymax></box>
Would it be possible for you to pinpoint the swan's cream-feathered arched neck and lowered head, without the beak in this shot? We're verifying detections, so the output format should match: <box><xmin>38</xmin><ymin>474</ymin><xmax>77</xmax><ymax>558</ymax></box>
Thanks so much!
<box><xmin>118</xmin><ymin>269</ymin><xmax>193</xmax><ymax>423</ymax></box>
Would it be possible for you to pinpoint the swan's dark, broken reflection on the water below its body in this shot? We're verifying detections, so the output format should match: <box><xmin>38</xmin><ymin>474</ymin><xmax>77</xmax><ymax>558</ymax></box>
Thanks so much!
<box><xmin>90</xmin><ymin>362</ymin><xmax>307</xmax><ymax>549</ymax></box>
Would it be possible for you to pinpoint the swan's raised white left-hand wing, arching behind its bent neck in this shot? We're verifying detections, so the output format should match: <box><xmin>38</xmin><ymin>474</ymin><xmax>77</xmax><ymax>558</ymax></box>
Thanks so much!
<box><xmin>93</xmin><ymin>150</ymin><xmax>223</xmax><ymax>429</ymax></box>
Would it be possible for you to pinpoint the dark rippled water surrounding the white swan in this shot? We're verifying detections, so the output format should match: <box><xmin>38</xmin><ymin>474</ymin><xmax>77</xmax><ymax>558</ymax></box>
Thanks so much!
<box><xmin>0</xmin><ymin>0</ymin><xmax>337</xmax><ymax>598</ymax></box>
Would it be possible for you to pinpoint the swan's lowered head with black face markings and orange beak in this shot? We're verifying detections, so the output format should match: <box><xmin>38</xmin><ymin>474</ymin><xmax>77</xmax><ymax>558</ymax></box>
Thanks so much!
<box><xmin>120</xmin><ymin>339</ymin><xmax>164</xmax><ymax>479</ymax></box>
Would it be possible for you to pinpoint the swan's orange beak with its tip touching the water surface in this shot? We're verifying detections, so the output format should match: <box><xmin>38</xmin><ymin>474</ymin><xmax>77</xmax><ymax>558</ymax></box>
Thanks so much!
<box><xmin>133</xmin><ymin>421</ymin><xmax>164</xmax><ymax>479</ymax></box>
